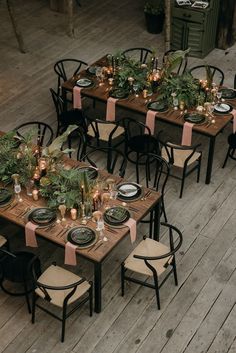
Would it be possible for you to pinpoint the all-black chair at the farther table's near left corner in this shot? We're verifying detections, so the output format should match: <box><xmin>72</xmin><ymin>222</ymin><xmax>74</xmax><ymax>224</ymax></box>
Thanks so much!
<box><xmin>50</xmin><ymin>88</ymin><xmax>87</xmax><ymax>136</ymax></box>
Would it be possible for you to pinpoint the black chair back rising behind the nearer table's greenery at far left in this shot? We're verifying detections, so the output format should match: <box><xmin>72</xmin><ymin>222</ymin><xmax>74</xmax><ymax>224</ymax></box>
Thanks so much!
<box><xmin>15</xmin><ymin>121</ymin><xmax>53</xmax><ymax>147</ymax></box>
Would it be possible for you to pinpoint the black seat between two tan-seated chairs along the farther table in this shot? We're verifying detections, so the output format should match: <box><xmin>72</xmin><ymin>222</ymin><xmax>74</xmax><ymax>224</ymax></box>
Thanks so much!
<box><xmin>128</xmin><ymin>135</ymin><xmax>158</xmax><ymax>153</ymax></box>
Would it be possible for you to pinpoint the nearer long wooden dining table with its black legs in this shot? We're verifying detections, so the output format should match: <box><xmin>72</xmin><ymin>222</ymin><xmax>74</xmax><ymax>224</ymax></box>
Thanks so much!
<box><xmin>0</xmin><ymin>154</ymin><xmax>161</xmax><ymax>313</ymax></box>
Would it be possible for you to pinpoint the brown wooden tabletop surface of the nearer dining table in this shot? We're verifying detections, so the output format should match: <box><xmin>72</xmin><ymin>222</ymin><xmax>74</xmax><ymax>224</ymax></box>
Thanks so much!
<box><xmin>0</xmin><ymin>159</ymin><xmax>160</xmax><ymax>262</ymax></box>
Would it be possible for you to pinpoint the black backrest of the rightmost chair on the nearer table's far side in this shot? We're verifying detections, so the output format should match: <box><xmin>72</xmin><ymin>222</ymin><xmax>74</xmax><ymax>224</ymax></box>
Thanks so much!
<box><xmin>140</xmin><ymin>153</ymin><xmax>170</xmax><ymax>197</ymax></box>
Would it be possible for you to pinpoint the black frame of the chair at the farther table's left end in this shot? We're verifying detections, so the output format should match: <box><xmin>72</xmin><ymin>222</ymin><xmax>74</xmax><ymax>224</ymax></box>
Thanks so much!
<box><xmin>54</xmin><ymin>59</ymin><xmax>88</xmax><ymax>95</ymax></box>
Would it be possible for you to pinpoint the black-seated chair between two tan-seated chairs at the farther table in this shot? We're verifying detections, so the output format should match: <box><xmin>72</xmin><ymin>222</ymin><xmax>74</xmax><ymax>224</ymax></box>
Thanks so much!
<box><xmin>120</xmin><ymin>118</ymin><xmax>159</xmax><ymax>183</ymax></box>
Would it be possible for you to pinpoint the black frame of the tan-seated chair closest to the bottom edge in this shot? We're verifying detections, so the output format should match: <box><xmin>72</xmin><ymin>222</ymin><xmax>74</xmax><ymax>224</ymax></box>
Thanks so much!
<box><xmin>31</xmin><ymin>263</ymin><xmax>93</xmax><ymax>342</ymax></box>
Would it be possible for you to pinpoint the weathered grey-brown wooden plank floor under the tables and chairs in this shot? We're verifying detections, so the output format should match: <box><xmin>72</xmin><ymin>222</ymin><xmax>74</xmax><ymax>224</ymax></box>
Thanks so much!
<box><xmin>0</xmin><ymin>0</ymin><xmax>236</xmax><ymax>353</ymax></box>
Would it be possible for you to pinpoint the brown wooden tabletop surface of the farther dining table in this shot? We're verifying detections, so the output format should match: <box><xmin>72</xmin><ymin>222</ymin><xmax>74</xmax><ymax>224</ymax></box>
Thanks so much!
<box><xmin>62</xmin><ymin>56</ymin><xmax>236</xmax><ymax>136</ymax></box>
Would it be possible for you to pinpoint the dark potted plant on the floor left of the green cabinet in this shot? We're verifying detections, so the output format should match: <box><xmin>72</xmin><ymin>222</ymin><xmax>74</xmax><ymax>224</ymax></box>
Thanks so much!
<box><xmin>144</xmin><ymin>0</ymin><xmax>165</xmax><ymax>34</ymax></box>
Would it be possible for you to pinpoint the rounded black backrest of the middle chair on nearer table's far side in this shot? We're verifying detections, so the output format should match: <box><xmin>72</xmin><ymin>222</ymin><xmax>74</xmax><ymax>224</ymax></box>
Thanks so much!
<box><xmin>82</xmin><ymin>147</ymin><xmax>127</xmax><ymax>177</ymax></box>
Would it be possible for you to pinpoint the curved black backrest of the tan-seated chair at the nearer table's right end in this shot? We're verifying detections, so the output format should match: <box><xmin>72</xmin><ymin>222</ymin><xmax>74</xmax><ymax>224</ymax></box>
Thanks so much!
<box><xmin>134</xmin><ymin>222</ymin><xmax>183</xmax><ymax>262</ymax></box>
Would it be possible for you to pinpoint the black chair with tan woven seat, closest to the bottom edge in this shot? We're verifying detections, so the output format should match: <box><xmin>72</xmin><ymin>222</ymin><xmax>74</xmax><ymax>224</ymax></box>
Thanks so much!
<box><xmin>31</xmin><ymin>263</ymin><xmax>93</xmax><ymax>342</ymax></box>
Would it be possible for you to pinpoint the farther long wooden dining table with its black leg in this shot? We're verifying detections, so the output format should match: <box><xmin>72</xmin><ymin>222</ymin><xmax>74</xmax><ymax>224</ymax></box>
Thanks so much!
<box><xmin>62</xmin><ymin>57</ymin><xmax>236</xmax><ymax>184</ymax></box>
